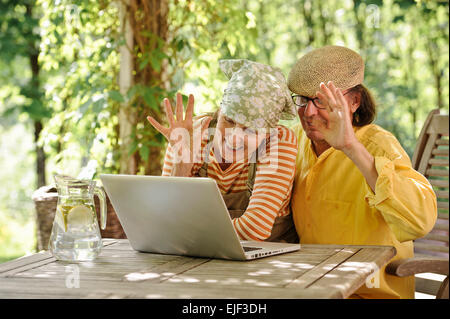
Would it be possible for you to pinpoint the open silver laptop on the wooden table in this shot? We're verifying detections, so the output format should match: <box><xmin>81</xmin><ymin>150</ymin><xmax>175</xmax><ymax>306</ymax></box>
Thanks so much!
<box><xmin>100</xmin><ymin>174</ymin><xmax>300</xmax><ymax>260</ymax></box>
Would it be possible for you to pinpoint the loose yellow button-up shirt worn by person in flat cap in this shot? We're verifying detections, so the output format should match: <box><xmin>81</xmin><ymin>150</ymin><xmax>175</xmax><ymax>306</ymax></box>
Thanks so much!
<box><xmin>291</xmin><ymin>124</ymin><xmax>437</xmax><ymax>298</ymax></box>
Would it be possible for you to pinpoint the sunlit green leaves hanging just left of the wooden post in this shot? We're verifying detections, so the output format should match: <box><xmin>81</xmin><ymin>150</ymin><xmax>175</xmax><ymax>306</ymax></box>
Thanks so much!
<box><xmin>40</xmin><ymin>0</ymin><xmax>123</xmax><ymax>177</ymax></box>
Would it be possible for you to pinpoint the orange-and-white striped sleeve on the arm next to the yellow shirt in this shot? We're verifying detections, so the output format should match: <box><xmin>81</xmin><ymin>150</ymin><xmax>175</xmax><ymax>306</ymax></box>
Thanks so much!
<box><xmin>233</xmin><ymin>127</ymin><xmax>297</xmax><ymax>241</ymax></box>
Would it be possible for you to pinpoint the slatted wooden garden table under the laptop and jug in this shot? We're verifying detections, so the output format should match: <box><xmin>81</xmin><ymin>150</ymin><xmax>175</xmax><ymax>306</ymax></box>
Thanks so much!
<box><xmin>0</xmin><ymin>239</ymin><xmax>395</xmax><ymax>299</ymax></box>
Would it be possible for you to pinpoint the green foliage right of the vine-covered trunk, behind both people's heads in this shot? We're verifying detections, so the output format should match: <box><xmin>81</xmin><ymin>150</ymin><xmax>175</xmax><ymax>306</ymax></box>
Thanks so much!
<box><xmin>172</xmin><ymin>0</ymin><xmax>449</xmax><ymax>155</ymax></box>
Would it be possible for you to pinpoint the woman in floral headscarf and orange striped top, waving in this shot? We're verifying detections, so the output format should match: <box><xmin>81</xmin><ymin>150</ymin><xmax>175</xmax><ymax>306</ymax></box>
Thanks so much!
<box><xmin>148</xmin><ymin>60</ymin><xmax>298</xmax><ymax>242</ymax></box>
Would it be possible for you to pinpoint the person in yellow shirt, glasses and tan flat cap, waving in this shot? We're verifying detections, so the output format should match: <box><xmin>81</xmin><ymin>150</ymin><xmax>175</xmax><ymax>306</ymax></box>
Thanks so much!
<box><xmin>288</xmin><ymin>46</ymin><xmax>437</xmax><ymax>298</ymax></box>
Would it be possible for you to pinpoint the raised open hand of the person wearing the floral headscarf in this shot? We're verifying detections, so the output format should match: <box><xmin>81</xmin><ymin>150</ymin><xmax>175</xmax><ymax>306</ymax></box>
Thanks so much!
<box><xmin>147</xmin><ymin>93</ymin><xmax>210</xmax><ymax>163</ymax></box>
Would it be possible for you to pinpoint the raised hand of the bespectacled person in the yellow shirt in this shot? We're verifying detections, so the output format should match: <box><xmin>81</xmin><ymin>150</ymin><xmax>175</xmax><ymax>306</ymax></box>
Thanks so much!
<box><xmin>313</xmin><ymin>81</ymin><xmax>358</xmax><ymax>151</ymax></box>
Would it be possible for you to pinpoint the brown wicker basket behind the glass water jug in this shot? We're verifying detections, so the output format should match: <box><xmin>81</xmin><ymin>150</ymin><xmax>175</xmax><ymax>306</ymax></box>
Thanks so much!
<box><xmin>33</xmin><ymin>185</ymin><xmax>127</xmax><ymax>250</ymax></box>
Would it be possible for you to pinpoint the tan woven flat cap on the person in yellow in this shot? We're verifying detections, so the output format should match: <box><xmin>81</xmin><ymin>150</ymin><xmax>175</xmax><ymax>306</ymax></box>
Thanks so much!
<box><xmin>288</xmin><ymin>45</ymin><xmax>364</xmax><ymax>97</ymax></box>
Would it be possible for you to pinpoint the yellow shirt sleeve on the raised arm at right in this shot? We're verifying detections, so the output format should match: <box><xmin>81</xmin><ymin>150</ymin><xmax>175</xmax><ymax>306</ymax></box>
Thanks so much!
<box><xmin>365</xmin><ymin>130</ymin><xmax>437</xmax><ymax>242</ymax></box>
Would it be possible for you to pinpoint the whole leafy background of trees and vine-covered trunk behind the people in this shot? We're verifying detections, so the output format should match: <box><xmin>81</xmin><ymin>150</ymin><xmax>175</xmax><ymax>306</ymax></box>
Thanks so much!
<box><xmin>0</xmin><ymin>0</ymin><xmax>449</xmax><ymax>261</ymax></box>
